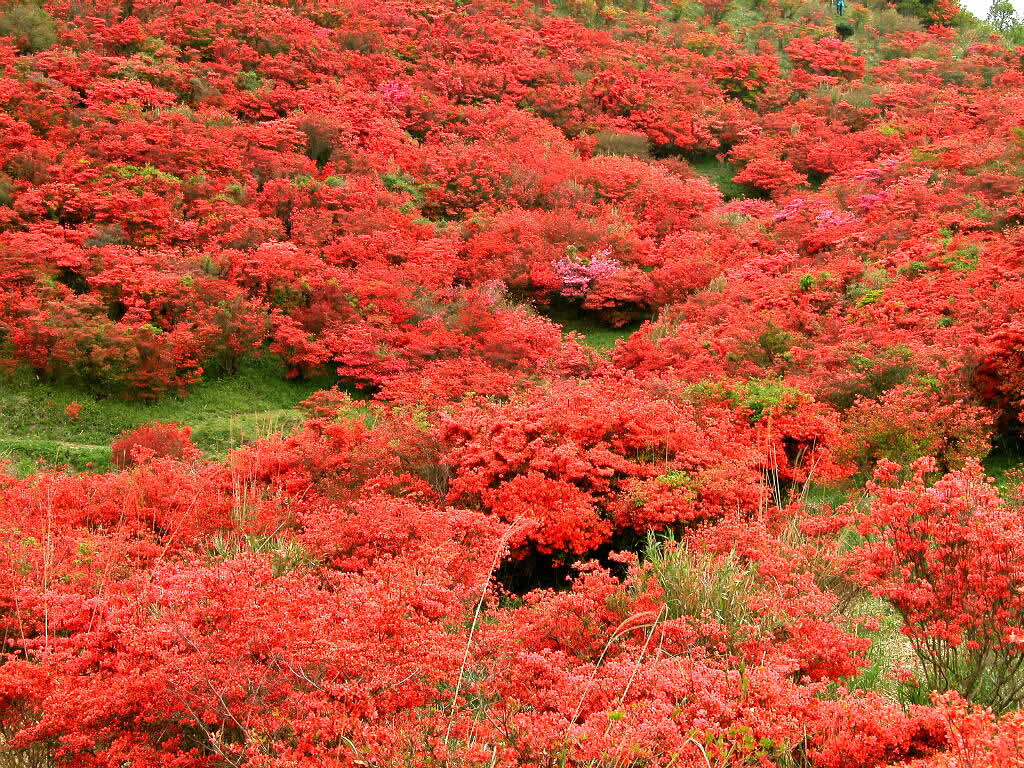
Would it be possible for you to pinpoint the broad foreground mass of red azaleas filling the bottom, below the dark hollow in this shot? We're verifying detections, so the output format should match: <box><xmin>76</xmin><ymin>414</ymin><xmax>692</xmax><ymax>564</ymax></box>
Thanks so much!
<box><xmin>0</xmin><ymin>450</ymin><xmax>944</xmax><ymax>766</ymax></box>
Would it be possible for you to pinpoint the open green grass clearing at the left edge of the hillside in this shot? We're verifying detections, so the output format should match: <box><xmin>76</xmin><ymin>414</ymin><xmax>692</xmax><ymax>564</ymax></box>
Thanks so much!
<box><xmin>0</xmin><ymin>358</ymin><xmax>336</xmax><ymax>474</ymax></box>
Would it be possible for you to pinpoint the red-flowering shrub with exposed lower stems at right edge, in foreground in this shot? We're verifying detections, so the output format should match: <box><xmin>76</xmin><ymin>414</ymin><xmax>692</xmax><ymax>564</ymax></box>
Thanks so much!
<box><xmin>853</xmin><ymin>458</ymin><xmax>1024</xmax><ymax>712</ymax></box>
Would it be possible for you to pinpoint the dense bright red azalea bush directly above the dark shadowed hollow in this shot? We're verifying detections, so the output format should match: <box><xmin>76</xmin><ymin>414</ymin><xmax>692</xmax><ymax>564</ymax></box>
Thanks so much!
<box><xmin>440</xmin><ymin>377</ymin><xmax>765</xmax><ymax>553</ymax></box>
